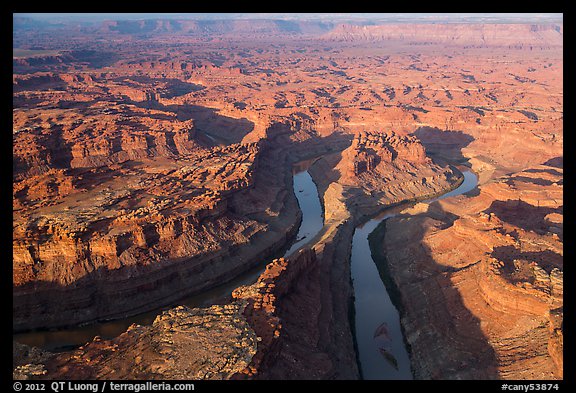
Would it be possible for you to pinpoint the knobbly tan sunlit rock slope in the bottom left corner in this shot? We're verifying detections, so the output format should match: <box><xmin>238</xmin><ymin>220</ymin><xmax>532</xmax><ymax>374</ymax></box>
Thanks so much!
<box><xmin>14</xmin><ymin>303</ymin><xmax>257</xmax><ymax>380</ymax></box>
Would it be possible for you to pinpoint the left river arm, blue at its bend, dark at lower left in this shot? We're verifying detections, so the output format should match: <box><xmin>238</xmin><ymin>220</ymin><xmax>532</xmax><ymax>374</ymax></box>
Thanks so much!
<box><xmin>13</xmin><ymin>160</ymin><xmax>324</xmax><ymax>352</ymax></box>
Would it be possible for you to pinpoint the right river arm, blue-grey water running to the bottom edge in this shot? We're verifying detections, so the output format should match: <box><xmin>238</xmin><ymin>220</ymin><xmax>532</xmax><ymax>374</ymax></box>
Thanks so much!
<box><xmin>350</xmin><ymin>171</ymin><xmax>478</xmax><ymax>379</ymax></box>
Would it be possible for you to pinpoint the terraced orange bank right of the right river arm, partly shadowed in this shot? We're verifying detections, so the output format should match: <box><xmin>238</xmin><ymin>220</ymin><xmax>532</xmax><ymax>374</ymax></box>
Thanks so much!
<box><xmin>373</xmin><ymin>166</ymin><xmax>563</xmax><ymax>379</ymax></box>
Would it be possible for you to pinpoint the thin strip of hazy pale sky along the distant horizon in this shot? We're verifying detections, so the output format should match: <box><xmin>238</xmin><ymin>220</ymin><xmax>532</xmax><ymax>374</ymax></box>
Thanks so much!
<box><xmin>12</xmin><ymin>13</ymin><xmax>563</xmax><ymax>23</ymax></box>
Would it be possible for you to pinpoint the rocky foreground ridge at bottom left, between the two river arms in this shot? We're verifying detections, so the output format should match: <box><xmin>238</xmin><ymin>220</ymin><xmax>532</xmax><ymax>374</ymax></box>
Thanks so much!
<box><xmin>14</xmin><ymin>249</ymin><xmax>357</xmax><ymax>379</ymax></box>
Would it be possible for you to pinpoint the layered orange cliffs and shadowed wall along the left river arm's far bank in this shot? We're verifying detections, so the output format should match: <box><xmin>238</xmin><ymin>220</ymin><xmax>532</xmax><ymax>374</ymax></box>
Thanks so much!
<box><xmin>13</xmin><ymin>115</ymin><xmax>300</xmax><ymax>329</ymax></box>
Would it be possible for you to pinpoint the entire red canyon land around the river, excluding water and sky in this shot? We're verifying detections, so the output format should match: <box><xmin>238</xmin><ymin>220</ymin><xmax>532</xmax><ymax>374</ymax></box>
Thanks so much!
<box><xmin>13</xmin><ymin>18</ymin><xmax>563</xmax><ymax>379</ymax></box>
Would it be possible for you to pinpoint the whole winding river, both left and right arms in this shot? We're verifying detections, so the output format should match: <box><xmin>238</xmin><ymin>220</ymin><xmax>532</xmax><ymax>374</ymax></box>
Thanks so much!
<box><xmin>13</xmin><ymin>160</ymin><xmax>477</xmax><ymax>379</ymax></box>
